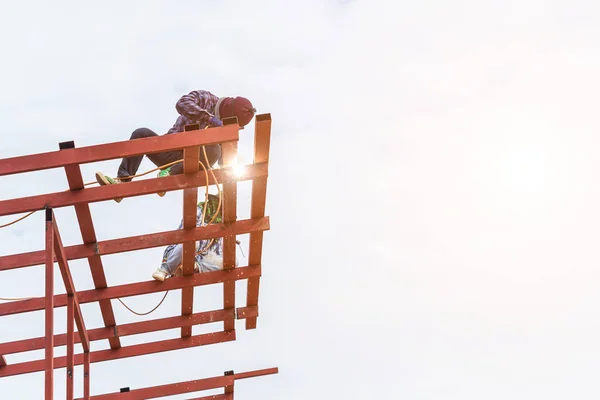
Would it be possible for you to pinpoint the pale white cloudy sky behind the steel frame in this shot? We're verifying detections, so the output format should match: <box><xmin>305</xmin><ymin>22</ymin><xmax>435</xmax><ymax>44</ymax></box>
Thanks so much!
<box><xmin>0</xmin><ymin>0</ymin><xmax>600</xmax><ymax>400</ymax></box>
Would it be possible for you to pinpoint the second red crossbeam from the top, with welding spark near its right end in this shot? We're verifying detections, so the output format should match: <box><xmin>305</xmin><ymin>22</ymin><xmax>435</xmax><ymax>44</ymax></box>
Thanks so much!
<box><xmin>0</xmin><ymin>161</ymin><xmax>268</xmax><ymax>216</ymax></box>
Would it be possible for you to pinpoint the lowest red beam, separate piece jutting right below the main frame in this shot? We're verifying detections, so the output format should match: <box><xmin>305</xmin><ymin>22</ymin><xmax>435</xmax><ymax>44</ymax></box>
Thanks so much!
<box><xmin>74</xmin><ymin>368</ymin><xmax>279</xmax><ymax>400</ymax></box>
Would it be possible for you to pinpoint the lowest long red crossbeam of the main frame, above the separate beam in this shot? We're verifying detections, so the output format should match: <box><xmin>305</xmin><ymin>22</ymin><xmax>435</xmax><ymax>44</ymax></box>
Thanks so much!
<box><xmin>0</xmin><ymin>331</ymin><xmax>236</xmax><ymax>378</ymax></box>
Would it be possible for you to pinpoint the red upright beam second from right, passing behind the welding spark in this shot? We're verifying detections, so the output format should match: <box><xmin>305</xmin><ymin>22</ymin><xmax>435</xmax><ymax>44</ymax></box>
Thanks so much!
<box><xmin>221</xmin><ymin>117</ymin><xmax>238</xmax><ymax>332</ymax></box>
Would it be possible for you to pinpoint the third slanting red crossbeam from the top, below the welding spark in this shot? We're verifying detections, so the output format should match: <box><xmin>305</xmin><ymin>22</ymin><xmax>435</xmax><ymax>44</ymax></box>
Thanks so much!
<box><xmin>0</xmin><ymin>217</ymin><xmax>270</xmax><ymax>271</ymax></box>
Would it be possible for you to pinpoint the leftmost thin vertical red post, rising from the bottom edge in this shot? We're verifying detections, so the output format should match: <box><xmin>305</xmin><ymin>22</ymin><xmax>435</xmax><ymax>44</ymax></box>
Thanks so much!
<box><xmin>44</xmin><ymin>208</ymin><xmax>54</xmax><ymax>400</ymax></box>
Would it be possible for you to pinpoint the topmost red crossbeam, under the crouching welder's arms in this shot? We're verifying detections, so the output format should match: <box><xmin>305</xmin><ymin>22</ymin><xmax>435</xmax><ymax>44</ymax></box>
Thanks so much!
<box><xmin>0</xmin><ymin>125</ymin><xmax>239</xmax><ymax>176</ymax></box>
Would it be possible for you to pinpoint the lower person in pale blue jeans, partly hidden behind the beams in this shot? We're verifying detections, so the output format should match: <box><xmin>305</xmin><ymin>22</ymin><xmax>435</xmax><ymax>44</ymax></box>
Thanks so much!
<box><xmin>152</xmin><ymin>194</ymin><xmax>230</xmax><ymax>282</ymax></box>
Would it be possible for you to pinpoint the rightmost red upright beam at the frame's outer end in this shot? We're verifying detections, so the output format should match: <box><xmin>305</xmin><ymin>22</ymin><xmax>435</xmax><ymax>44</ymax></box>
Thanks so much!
<box><xmin>246</xmin><ymin>114</ymin><xmax>271</xmax><ymax>329</ymax></box>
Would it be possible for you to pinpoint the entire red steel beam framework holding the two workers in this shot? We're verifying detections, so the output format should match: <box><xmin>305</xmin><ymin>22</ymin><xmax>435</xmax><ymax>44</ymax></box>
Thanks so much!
<box><xmin>0</xmin><ymin>114</ymin><xmax>277</xmax><ymax>400</ymax></box>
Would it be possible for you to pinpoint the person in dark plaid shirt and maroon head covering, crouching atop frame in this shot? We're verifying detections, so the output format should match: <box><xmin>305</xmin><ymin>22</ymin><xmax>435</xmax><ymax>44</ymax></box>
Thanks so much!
<box><xmin>96</xmin><ymin>90</ymin><xmax>256</xmax><ymax>203</ymax></box>
